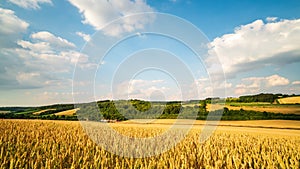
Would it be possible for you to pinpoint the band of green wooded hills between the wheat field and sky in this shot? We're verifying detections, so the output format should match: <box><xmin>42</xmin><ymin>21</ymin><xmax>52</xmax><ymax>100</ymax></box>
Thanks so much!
<box><xmin>0</xmin><ymin>93</ymin><xmax>300</xmax><ymax>121</ymax></box>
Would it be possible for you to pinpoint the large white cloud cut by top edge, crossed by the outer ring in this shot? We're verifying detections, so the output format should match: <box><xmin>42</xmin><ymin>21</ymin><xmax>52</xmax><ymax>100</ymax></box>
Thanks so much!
<box><xmin>69</xmin><ymin>0</ymin><xmax>154</xmax><ymax>36</ymax></box>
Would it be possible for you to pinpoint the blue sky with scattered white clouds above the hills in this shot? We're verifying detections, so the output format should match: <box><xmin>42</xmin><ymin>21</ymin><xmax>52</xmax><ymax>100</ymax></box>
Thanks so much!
<box><xmin>0</xmin><ymin>0</ymin><xmax>300</xmax><ymax>106</ymax></box>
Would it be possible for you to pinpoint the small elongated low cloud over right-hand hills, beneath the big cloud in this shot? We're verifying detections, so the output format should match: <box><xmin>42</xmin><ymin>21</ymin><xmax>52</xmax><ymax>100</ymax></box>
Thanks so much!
<box><xmin>234</xmin><ymin>74</ymin><xmax>290</xmax><ymax>95</ymax></box>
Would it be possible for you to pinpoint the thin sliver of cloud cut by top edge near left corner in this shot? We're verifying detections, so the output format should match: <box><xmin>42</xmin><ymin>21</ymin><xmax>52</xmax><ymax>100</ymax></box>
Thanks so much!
<box><xmin>9</xmin><ymin>0</ymin><xmax>52</xmax><ymax>9</ymax></box>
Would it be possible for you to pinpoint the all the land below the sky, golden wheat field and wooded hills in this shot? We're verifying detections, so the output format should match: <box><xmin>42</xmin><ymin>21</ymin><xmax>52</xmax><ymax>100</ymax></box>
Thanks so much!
<box><xmin>0</xmin><ymin>94</ymin><xmax>300</xmax><ymax>168</ymax></box>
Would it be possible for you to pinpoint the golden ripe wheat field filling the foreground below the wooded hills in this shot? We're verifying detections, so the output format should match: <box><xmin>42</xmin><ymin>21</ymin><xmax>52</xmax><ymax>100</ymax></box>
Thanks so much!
<box><xmin>0</xmin><ymin>119</ymin><xmax>300</xmax><ymax>168</ymax></box>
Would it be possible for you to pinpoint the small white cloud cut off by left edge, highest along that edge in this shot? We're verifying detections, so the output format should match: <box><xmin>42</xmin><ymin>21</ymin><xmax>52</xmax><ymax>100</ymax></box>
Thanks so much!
<box><xmin>0</xmin><ymin>8</ymin><xmax>29</xmax><ymax>48</ymax></box>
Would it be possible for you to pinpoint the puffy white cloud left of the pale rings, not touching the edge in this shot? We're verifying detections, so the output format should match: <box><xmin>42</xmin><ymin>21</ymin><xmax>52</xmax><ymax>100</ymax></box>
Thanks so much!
<box><xmin>12</xmin><ymin>31</ymin><xmax>88</xmax><ymax>72</ymax></box>
